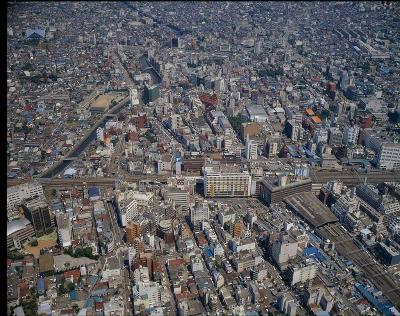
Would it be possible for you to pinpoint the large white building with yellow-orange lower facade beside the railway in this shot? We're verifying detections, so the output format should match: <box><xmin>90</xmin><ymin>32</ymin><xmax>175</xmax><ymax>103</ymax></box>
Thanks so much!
<box><xmin>203</xmin><ymin>162</ymin><xmax>251</xmax><ymax>197</ymax></box>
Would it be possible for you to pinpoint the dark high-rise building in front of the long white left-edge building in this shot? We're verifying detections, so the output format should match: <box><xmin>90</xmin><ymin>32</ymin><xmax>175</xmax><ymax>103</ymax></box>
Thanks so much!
<box><xmin>22</xmin><ymin>197</ymin><xmax>55</xmax><ymax>237</ymax></box>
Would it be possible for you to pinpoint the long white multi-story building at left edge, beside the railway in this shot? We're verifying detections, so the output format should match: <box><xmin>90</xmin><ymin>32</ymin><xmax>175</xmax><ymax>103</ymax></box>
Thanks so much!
<box><xmin>7</xmin><ymin>182</ymin><xmax>43</xmax><ymax>212</ymax></box>
